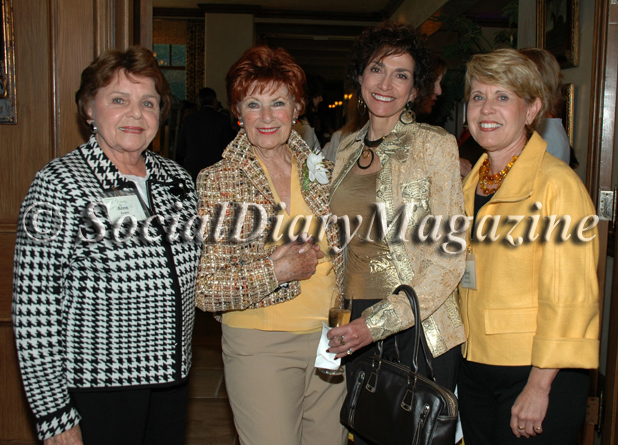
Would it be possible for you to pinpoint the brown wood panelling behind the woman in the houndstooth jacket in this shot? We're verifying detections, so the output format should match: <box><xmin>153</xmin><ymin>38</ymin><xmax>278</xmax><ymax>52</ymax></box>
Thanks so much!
<box><xmin>0</xmin><ymin>0</ymin><xmax>152</xmax><ymax>438</ymax></box>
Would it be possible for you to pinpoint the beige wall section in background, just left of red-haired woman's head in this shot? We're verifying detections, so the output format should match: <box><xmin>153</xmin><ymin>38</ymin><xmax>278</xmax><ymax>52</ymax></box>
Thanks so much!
<box><xmin>204</xmin><ymin>14</ymin><xmax>254</xmax><ymax>108</ymax></box>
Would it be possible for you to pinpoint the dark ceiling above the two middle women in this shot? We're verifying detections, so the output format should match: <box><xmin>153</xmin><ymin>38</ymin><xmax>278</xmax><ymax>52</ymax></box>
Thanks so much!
<box><xmin>153</xmin><ymin>0</ymin><xmax>509</xmax><ymax>87</ymax></box>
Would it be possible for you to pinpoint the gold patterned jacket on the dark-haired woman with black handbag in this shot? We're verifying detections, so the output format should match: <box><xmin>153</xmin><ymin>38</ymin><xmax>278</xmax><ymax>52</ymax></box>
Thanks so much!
<box><xmin>331</xmin><ymin>122</ymin><xmax>466</xmax><ymax>357</ymax></box>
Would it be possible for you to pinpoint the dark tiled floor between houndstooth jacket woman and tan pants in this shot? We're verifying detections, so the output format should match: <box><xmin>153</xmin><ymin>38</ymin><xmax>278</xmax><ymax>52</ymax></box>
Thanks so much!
<box><xmin>185</xmin><ymin>310</ymin><xmax>239</xmax><ymax>445</ymax></box>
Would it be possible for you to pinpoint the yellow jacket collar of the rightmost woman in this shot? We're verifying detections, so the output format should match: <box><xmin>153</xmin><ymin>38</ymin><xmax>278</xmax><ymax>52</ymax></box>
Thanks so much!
<box><xmin>463</xmin><ymin>131</ymin><xmax>547</xmax><ymax>204</ymax></box>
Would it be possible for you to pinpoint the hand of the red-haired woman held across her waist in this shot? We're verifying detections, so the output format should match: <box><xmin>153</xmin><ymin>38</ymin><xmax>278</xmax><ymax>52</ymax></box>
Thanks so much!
<box><xmin>270</xmin><ymin>237</ymin><xmax>324</xmax><ymax>283</ymax></box>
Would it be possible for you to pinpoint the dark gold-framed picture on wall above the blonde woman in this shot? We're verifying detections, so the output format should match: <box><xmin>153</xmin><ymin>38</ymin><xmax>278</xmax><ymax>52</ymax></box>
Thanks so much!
<box><xmin>536</xmin><ymin>0</ymin><xmax>579</xmax><ymax>68</ymax></box>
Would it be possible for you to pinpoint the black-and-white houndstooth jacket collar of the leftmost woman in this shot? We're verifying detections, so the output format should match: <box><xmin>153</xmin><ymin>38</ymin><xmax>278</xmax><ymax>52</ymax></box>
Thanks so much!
<box><xmin>78</xmin><ymin>134</ymin><xmax>171</xmax><ymax>190</ymax></box>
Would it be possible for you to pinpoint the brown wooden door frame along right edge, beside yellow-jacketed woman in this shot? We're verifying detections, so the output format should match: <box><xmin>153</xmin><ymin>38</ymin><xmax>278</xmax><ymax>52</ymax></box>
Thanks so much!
<box><xmin>582</xmin><ymin>0</ymin><xmax>618</xmax><ymax>445</ymax></box>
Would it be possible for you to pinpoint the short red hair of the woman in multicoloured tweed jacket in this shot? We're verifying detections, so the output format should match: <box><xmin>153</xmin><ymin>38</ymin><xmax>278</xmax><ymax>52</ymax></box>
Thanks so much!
<box><xmin>225</xmin><ymin>46</ymin><xmax>306</xmax><ymax>117</ymax></box>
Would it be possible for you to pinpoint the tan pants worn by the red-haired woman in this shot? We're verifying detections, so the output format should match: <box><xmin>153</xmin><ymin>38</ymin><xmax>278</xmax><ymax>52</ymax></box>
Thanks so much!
<box><xmin>222</xmin><ymin>325</ymin><xmax>348</xmax><ymax>445</ymax></box>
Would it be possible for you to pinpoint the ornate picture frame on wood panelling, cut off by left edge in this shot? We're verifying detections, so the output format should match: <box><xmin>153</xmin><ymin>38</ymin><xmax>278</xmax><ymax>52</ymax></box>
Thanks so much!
<box><xmin>0</xmin><ymin>0</ymin><xmax>17</xmax><ymax>124</ymax></box>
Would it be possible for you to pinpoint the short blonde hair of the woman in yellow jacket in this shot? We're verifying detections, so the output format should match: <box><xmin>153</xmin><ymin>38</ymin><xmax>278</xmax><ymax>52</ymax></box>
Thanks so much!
<box><xmin>465</xmin><ymin>48</ymin><xmax>547</xmax><ymax>132</ymax></box>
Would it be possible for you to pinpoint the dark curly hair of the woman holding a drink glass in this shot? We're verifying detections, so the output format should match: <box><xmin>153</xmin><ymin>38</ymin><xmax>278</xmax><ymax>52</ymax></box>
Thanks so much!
<box><xmin>347</xmin><ymin>21</ymin><xmax>435</xmax><ymax>104</ymax></box>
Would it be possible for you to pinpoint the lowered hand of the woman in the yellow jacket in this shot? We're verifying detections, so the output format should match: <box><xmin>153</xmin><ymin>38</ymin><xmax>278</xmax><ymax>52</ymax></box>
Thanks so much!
<box><xmin>511</xmin><ymin>367</ymin><xmax>560</xmax><ymax>438</ymax></box>
